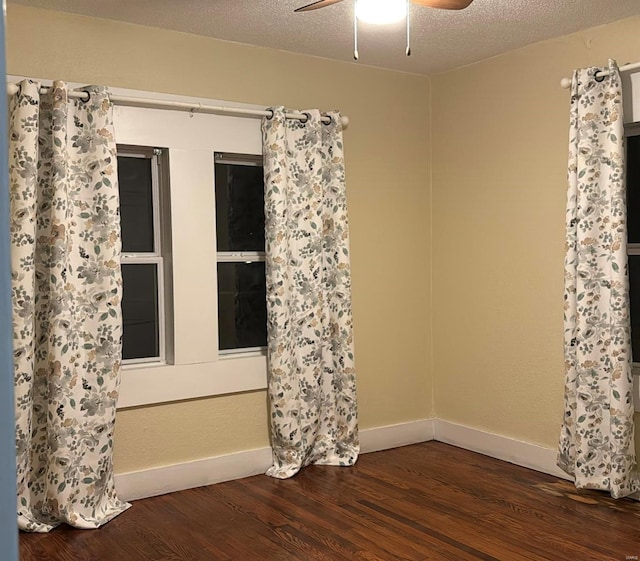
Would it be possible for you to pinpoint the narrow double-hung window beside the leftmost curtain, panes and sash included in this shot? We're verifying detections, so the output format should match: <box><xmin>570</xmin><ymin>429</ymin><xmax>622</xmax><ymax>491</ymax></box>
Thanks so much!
<box><xmin>118</xmin><ymin>145</ymin><xmax>170</xmax><ymax>364</ymax></box>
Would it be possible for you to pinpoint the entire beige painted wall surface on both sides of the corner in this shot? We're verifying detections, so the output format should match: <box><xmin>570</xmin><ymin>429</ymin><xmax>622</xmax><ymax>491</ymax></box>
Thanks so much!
<box><xmin>7</xmin><ymin>4</ymin><xmax>640</xmax><ymax>472</ymax></box>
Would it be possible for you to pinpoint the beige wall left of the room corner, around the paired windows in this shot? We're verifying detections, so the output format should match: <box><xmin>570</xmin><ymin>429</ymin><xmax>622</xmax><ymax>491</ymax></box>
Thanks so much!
<box><xmin>7</xmin><ymin>4</ymin><xmax>432</xmax><ymax>472</ymax></box>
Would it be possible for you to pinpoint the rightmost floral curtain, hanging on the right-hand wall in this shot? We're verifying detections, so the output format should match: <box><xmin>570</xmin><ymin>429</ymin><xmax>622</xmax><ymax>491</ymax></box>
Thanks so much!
<box><xmin>558</xmin><ymin>61</ymin><xmax>640</xmax><ymax>498</ymax></box>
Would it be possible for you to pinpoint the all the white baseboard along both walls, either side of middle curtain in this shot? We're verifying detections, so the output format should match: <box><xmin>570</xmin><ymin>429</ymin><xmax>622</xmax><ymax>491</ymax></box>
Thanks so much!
<box><xmin>115</xmin><ymin>419</ymin><xmax>570</xmax><ymax>501</ymax></box>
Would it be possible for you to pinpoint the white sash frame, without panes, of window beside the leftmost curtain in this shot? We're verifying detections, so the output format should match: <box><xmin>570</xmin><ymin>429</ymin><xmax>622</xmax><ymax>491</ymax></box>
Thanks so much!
<box><xmin>118</xmin><ymin>145</ymin><xmax>167</xmax><ymax>368</ymax></box>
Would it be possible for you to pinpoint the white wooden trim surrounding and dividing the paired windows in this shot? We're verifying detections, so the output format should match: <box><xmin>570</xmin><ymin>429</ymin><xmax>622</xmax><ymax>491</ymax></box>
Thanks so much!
<box><xmin>7</xmin><ymin>75</ymin><xmax>267</xmax><ymax>409</ymax></box>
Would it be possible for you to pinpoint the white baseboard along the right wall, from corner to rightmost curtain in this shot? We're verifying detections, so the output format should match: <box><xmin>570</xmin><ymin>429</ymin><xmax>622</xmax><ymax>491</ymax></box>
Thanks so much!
<box><xmin>435</xmin><ymin>419</ymin><xmax>572</xmax><ymax>480</ymax></box>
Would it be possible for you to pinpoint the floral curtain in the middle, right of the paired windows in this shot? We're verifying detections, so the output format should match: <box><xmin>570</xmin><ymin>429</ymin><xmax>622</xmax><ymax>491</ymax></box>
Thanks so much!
<box><xmin>262</xmin><ymin>107</ymin><xmax>359</xmax><ymax>478</ymax></box>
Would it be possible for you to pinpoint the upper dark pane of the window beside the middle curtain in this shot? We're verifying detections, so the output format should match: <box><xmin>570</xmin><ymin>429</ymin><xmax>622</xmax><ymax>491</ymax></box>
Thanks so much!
<box><xmin>215</xmin><ymin>163</ymin><xmax>264</xmax><ymax>251</ymax></box>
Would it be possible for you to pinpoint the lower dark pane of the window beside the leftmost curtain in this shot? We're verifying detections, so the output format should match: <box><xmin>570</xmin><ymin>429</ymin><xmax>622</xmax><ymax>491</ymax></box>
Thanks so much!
<box><xmin>122</xmin><ymin>263</ymin><xmax>160</xmax><ymax>359</ymax></box>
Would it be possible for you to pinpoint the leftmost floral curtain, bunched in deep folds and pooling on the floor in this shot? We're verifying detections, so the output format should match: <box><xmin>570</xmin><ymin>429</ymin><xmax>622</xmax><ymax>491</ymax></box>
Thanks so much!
<box><xmin>9</xmin><ymin>80</ymin><xmax>129</xmax><ymax>532</ymax></box>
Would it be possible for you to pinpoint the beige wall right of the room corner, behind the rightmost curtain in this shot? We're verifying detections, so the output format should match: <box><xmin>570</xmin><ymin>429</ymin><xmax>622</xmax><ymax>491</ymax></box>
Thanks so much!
<box><xmin>432</xmin><ymin>17</ymin><xmax>640</xmax><ymax>447</ymax></box>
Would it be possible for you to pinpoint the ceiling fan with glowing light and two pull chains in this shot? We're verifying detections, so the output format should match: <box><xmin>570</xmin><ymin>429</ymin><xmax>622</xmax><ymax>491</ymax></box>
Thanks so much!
<box><xmin>294</xmin><ymin>0</ymin><xmax>473</xmax><ymax>60</ymax></box>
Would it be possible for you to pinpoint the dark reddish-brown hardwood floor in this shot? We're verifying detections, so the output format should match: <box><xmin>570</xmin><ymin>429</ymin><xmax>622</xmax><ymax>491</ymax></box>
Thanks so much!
<box><xmin>20</xmin><ymin>442</ymin><xmax>640</xmax><ymax>561</ymax></box>
